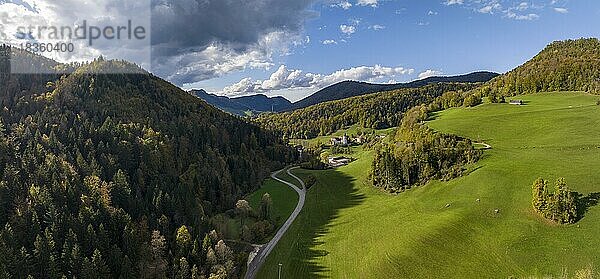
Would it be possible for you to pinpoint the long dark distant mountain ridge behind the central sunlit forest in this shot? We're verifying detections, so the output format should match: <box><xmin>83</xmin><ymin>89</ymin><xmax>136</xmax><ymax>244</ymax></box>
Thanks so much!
<box><xmin>291</xmin><ymin>72</ymin><xmax>499</xmax><ymax>109</ymax></box>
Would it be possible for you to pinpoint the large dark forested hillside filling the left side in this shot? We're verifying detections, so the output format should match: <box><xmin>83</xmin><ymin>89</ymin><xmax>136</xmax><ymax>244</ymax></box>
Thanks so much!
<box><xmin>0</xmin><ymin>47</ymin><xmax>296</xmax><ymax>278</ymax></box>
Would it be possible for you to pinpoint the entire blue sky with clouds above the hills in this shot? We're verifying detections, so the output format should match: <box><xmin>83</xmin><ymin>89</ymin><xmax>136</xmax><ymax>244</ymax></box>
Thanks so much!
<box><xmin>0</xmin><ymin>0</ymin><xmax>600</xmax><ymax>100</ymax></box>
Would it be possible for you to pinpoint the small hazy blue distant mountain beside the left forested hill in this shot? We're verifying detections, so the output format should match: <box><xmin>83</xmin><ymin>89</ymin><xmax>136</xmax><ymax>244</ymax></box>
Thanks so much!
<box><xmin>190</xmin><ymin>90</ymin><xmax>292</xmax><ymax>116</ymax></box>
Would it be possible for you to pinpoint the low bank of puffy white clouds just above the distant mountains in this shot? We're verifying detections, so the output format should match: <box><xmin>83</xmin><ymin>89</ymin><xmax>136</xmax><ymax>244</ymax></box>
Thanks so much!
<box><xmin>219</xmin><ymin>65</ymin><xmax>414</xmax><ymax>95</ymax></box>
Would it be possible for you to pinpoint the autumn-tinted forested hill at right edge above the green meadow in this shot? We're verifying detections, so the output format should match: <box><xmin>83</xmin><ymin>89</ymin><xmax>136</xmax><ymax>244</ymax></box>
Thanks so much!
<box><xmin>482</xmin><ymin>38</ymin><xmax>600</xmax><ymax>96</ymax></box>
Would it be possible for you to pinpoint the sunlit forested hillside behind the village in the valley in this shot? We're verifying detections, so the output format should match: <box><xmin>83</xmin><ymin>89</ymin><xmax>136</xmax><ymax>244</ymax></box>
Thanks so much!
<box><xmin>257</xmin><ymin>83</ymin><xmax>480</xmax><ymax>138</ymax></box>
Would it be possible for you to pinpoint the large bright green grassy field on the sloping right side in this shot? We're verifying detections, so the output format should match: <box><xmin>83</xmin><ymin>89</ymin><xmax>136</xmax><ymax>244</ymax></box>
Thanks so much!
<box><xmin>258</xmin><ymin>93</ymin><xmax>600</xmax><ymax>278</ymax></box>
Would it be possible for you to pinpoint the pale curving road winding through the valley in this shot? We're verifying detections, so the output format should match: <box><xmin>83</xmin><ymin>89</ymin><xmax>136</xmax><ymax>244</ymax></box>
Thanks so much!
<box><xmin>244</xmin><ymin>167</ymin><xmax>306</xmax><ymax>279</ymax></box>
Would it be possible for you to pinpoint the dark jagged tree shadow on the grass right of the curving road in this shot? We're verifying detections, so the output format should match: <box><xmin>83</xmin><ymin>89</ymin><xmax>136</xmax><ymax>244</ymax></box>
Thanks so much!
<box><xmin>286</xmin><ymin>167</ymin><xmax>365</xmax><ymax>278</ymax></box>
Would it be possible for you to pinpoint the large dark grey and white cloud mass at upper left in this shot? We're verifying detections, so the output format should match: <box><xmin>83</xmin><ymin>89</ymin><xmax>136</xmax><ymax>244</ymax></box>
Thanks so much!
<box><xmin>0</xmin><ymin>0</ymin><xmax>318</xmax><ymax>85</ymax></box>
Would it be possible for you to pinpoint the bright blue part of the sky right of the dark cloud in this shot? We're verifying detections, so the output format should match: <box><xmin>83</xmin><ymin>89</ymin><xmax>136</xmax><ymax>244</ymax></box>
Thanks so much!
<box><xmin>184</xmin><ymin>0</ymin><xmax>600</xmax><ymax>103</ymax></box>
